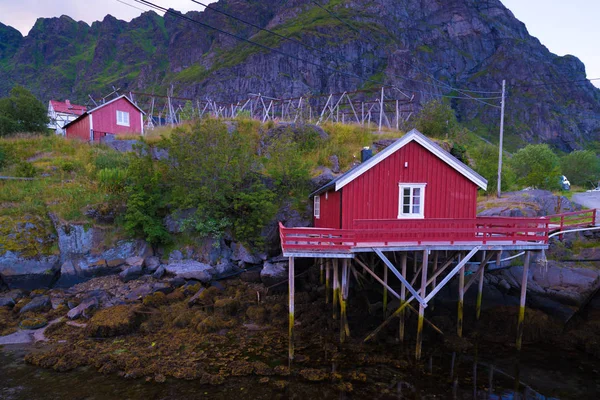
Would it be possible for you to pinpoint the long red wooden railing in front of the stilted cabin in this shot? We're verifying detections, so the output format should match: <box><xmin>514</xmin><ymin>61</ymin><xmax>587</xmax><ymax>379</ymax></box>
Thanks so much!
<box><xmin>279</xmin><ymin>217</ymin><xmax>550</xmax><ymax>251</ymax></box>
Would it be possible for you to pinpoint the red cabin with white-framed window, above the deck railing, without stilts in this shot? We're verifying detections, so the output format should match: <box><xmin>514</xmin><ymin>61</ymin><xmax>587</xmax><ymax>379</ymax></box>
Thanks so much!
<box><xmin>311</xmin><ymin>129</ymin><xmax>487</xmax><ymax>229</ymax></box>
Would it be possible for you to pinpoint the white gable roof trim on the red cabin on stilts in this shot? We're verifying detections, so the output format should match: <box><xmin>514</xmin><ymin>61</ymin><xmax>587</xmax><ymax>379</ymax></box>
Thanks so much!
<box><xmin>335</xmin><ymin>129</ymin><xmax>487</xmax><ymax>191</ymax></box>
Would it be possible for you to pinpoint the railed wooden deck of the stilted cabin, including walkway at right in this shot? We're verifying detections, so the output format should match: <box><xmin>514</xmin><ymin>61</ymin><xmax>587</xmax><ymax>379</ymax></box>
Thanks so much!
<box><xmin>279</xmin><ymin>210</ymin><xmax>596</xmax><ymax>258</ymax></box>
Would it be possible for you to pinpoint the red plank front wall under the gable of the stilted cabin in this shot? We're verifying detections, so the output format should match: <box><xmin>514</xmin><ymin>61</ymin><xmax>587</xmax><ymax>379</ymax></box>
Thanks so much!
<box><xmin>340</xmin><ymin>141</ymin><xmax>477</xmax><ymax>229</ymax></box>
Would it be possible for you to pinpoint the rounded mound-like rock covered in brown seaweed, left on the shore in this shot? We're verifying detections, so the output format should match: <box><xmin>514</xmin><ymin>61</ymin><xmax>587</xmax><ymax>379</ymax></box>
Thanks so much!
<box><xmin>86</xmin><ymin>305</ymin><xmax>143</xmax><ymax>337</ymax></box>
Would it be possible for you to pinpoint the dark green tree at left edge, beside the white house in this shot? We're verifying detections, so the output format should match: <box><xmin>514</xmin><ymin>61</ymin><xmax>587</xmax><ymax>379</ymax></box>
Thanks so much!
<box><xmin>0</xmin><ymin>86</ymin><xmax>48</xmax><ymax>136</ymax></box>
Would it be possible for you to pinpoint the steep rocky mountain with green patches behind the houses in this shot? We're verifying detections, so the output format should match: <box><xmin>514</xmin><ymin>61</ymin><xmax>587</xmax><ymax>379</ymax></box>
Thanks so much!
<box><xmin>0</xmin><ymin>0</ymin><xmax>600</xmax><ymax>150</ymax></box>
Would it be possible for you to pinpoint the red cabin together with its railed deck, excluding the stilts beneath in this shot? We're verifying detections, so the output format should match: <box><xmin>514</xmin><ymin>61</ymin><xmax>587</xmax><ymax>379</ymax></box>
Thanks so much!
<box><xmin>281</xmin><ymin>129</ymin><xmax>548</xmax><ymax>257</ymax></box>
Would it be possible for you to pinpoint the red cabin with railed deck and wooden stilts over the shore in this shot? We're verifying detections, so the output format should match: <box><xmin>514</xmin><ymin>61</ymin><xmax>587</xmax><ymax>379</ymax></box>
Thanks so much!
<box><xmin>280</xmin><ymin>130</ymin><xmax>595</xmax><ymax>359</ymax></box>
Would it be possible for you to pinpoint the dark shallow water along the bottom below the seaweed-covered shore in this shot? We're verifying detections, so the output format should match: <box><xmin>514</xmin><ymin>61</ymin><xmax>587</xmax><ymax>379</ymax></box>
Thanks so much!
<box><xmin>0</xmin><ymin>346</ymin><xmax>600</xmax><ymax>400</ymax></box>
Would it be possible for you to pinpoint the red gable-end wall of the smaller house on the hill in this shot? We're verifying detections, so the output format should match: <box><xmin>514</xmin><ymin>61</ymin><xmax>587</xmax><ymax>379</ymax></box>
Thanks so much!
<box><xmin>92</xmin><ymin>98</ymin><xmax>142</xmax><ymax>135</ymax></box>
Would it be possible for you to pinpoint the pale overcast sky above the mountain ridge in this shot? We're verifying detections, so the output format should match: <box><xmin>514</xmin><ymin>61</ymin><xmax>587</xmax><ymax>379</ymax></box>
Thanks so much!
<box><xmin>0</xmin><ymin>0</ymin><xmax>600</xmax><ymax>87</ymax></box>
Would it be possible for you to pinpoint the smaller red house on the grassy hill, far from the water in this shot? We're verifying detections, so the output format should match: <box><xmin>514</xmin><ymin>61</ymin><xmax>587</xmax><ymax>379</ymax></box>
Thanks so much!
<box><xmin>65</xmin><ymin>95</ymin><xmax>145</xmax><ymax>142</ymax></box>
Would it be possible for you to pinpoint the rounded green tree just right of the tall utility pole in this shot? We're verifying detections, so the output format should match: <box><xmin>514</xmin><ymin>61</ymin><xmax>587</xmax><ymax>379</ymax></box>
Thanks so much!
<box><xmin>510</xmin><ymin>144</ymin><xmax>561</xmax><ymax>190</ymax></box>
